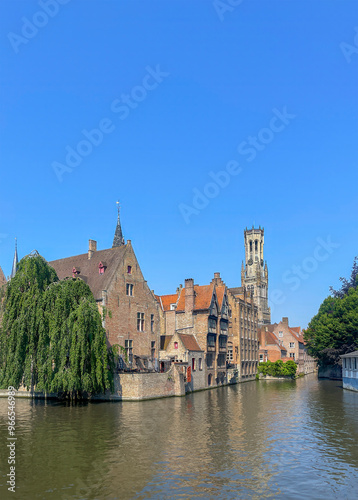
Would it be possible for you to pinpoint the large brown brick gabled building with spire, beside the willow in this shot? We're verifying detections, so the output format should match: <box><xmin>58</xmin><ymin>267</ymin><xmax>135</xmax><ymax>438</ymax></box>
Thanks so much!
<box><xmin>49</xmin><ymin>211</ymin><xmax>160</xmax><ymax>369</ymax></box>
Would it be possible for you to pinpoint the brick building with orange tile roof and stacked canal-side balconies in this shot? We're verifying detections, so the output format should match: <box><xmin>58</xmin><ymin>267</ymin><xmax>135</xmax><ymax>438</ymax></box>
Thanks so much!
<box><xmin>157</xmin><ymin>273</ymin><xmax>229</xmax><ymax>388</ymax></box>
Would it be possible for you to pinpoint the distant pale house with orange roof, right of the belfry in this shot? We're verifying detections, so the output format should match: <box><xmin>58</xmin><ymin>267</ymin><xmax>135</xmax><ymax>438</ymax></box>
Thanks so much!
<box><xmin>260</xmin><ymin>317</ymin><xmax>316</xmax><ymax>373</ymax></box>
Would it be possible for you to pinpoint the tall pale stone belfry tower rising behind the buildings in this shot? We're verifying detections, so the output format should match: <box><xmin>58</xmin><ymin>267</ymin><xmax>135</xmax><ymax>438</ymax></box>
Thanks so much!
<box><xmin>241</xmin><ymin>226</ymin><xmax>271</xmax><ymax>326</ymax></box>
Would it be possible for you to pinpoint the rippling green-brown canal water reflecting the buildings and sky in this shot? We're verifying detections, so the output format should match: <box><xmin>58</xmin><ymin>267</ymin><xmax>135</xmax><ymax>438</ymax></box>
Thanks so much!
<box><xmin>0</xmin><ymin>375</ymin><xmax>358</xmax><ymax>500</ymax></box>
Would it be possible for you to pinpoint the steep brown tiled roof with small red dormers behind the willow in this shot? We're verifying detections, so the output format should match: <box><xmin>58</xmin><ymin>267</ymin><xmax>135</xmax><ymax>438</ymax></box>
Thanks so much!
<box><xmin>49</xmin><ymin>243</ymin><xmax>128</xmax><ymax>299</ymax></box>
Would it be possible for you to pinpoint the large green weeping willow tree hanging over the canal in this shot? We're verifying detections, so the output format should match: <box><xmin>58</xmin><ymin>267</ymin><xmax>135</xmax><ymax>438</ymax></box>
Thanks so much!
<box><xmin>0</xmin><ymin>254</ymin><xmax>113</xmax><ymax>398</ymax></box>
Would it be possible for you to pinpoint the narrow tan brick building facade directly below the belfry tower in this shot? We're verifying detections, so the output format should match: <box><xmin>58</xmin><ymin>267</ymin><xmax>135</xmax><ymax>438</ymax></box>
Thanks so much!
<box><xmin>228</xmin><ymin>287</ymin><xmax>259</xmax><ymax>380</ymax></box>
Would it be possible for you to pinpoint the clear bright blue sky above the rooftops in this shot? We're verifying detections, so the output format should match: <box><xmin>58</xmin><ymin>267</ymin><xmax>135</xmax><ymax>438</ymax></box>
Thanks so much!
<box><xmin>0</xmin><ymin>0</ymin><xmax>358</xmax><ymax>327</ymax></box>
